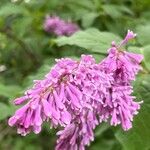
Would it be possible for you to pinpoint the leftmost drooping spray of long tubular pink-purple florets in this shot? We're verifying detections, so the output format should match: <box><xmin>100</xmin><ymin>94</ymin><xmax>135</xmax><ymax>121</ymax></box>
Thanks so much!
<box><xmin>9</xmin><ymin>58</ymin><xmax>82</xmax><ymax>135</ymax></box>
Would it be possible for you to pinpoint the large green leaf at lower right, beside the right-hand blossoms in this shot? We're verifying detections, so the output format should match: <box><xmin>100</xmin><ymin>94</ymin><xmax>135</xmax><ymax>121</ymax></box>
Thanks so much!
<box><xmin>115</xmin><ymin>75</ymin><xmax>150</xmax><ymax>150</ymax></box>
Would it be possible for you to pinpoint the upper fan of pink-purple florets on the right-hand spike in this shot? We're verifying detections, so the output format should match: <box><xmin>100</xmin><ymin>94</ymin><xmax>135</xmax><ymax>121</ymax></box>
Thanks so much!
<box><xmin>101</xmin><ymin>43</ymin><xmax>143</xmax><ymax>82</ymax></box>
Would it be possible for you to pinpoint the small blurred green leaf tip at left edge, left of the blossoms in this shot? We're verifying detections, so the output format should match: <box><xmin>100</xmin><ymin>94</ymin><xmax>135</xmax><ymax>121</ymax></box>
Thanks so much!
<box><xmin>0</xmin><ymin>83</ymin><xmax>22</xmax><ymax>98</ymax></box>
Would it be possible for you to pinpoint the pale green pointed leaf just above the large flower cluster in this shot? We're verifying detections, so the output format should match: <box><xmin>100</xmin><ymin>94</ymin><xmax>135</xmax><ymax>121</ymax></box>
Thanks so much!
<box><xmin>55</xmin><ymin>28</ymin><xmax>121</xmax><ymax>53</ymax></box>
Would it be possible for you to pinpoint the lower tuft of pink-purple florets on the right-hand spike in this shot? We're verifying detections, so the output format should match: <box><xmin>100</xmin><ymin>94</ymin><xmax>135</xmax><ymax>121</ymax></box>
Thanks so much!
<box><xmin>103</xmin><ymin>85</ymin><xmax>141</xmax><ymax>130</ymax></box>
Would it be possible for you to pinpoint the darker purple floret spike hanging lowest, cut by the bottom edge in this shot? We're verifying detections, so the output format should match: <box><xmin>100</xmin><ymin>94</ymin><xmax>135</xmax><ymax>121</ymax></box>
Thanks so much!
<box><xmin>55</xmin><ymin>109</ymin><xmax>98</xmax><ymax>150</ymax></box>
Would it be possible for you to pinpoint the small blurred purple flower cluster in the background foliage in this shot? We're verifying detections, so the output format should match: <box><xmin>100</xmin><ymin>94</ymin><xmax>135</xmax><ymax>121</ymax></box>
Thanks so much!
<box><xmin>44</xmin><ymin>16</ymin><xmax>79</xmax><ymax>36</ymax></box>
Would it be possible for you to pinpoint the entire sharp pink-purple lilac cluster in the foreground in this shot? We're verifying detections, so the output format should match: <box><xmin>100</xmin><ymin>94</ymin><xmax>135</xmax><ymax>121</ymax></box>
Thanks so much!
<box><xmin>9</xmin><ymin>31</ymin><xmax>143</xmax><ymax>150</ymax></box>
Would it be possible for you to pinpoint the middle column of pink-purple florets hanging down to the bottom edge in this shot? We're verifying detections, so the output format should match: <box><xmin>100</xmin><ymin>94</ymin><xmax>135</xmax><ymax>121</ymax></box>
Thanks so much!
<box><xmin>56</xmin><ymin>55</ymin><xmax>113</xmax><ymax>150</ymax></box>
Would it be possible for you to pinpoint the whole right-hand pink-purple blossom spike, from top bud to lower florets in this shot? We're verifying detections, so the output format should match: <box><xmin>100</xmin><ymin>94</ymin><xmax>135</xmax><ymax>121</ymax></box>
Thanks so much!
<box><xmin>99</xmin><ymin>31</ymin><xmax>143</xmax><ymax>130</ymax></box>
